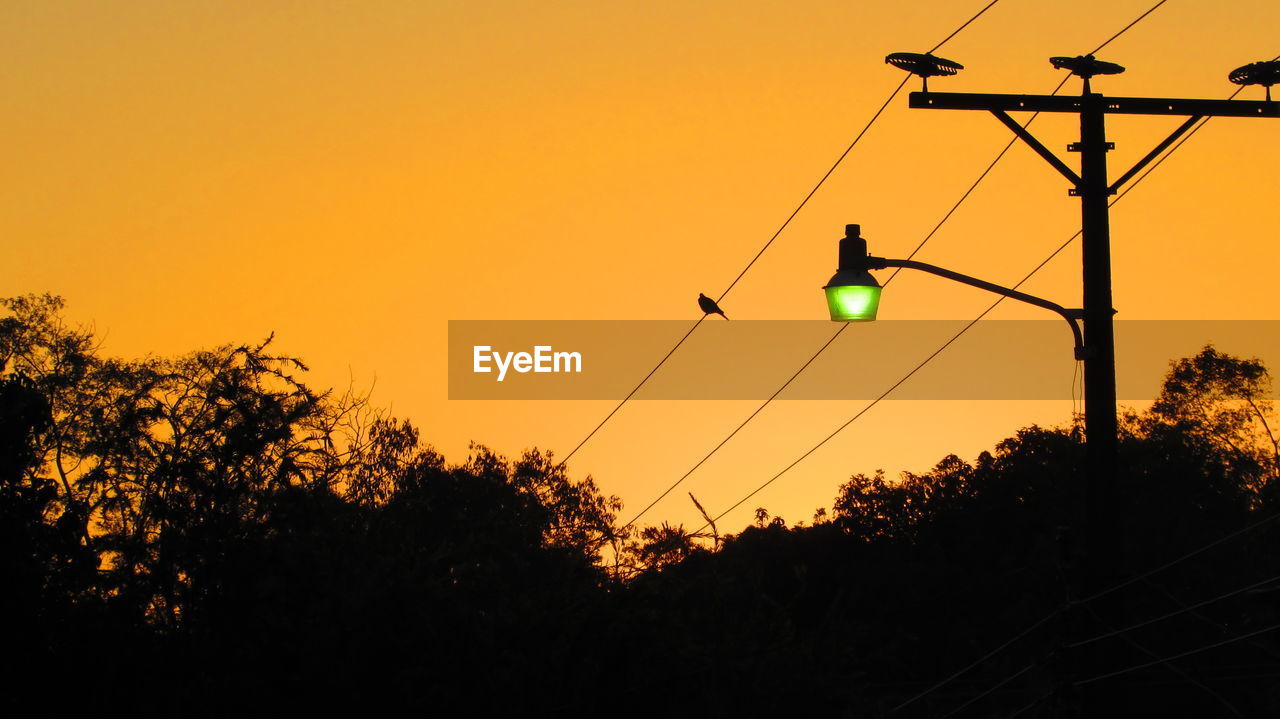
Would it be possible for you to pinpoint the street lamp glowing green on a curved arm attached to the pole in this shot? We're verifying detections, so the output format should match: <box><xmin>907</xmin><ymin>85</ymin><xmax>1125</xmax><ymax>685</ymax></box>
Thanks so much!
<box><xmin>823</xmin><ymin>225</ymin><xmax>1087</xmax><ymax>360</ymax></box>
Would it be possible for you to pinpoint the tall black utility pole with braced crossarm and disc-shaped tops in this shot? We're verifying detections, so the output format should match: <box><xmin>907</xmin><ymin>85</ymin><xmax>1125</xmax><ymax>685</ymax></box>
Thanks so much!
<box><xmin>886</xmin><ymin>52</ymin><xmax>1280</xmax><ymax>719</ymax></box>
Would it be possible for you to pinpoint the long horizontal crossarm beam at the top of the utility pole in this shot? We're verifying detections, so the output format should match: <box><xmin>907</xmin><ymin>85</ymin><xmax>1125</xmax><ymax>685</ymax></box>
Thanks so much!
<box><xmin>908</xmin><ymin>92</ymin><xmax>1280</xmax><ymax>118</ymax></box>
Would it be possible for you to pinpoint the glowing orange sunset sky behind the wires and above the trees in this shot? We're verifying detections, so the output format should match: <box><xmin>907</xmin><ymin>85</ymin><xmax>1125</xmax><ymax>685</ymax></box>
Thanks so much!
<box><xmin>0</xmin><ymin>0</ymin><xmax>1280</xmax><ymax>526</ymax></box>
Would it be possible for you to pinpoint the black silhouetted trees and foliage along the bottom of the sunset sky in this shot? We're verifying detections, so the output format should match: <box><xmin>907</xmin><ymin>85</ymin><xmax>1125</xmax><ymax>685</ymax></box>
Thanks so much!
<box><xmin>0</xmin><ymin>297</ymin><xmax>1280</xmax><ymax>716</ymax></box>
